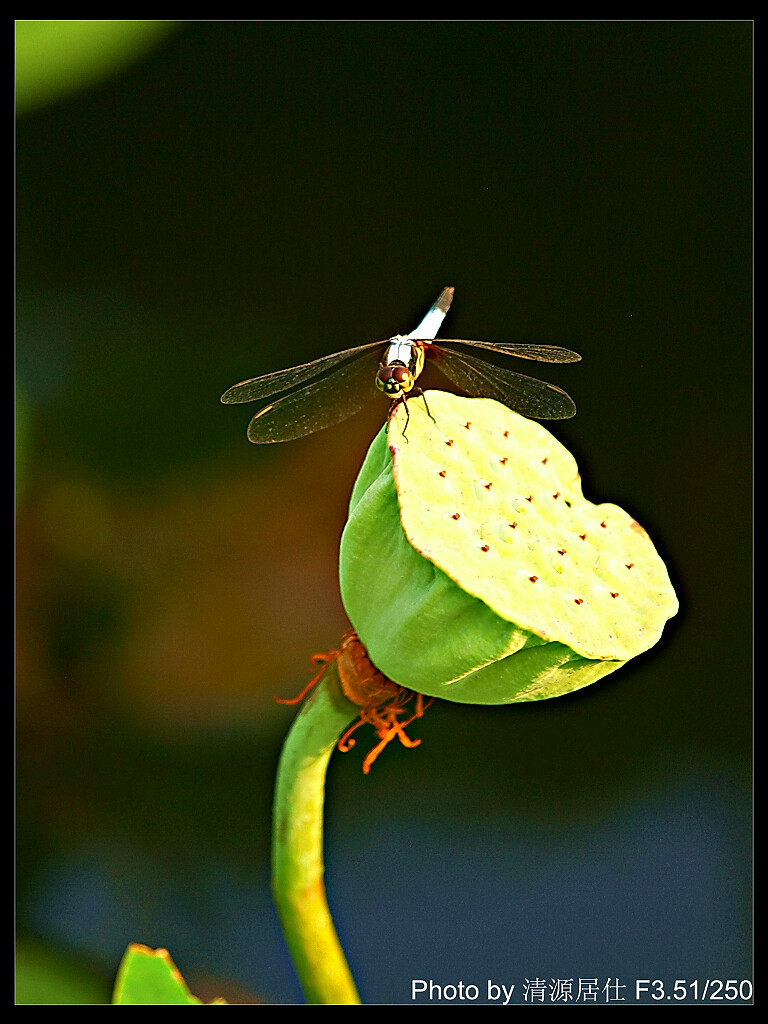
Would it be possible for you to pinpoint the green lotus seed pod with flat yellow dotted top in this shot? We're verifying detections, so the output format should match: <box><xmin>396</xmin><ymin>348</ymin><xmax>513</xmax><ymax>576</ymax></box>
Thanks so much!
<box><xmin>340</xmin><ymin>391</ymin><xmax>678</xmax><ymax>703</ymax></box>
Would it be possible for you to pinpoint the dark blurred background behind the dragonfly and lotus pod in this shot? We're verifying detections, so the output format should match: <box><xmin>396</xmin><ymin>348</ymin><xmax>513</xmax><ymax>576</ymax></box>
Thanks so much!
<box><xmin>15</xmin><ymin>22</ymin><xmax>753</xmax><ymax>1004</ymax></box>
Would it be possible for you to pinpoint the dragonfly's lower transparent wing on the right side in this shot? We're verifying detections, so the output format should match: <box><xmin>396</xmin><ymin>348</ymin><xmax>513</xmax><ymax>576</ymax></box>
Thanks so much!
<box><xmin>431</xmin><ymin>345</ymin><xmax>575</xmax><ymax>420</ymax></box>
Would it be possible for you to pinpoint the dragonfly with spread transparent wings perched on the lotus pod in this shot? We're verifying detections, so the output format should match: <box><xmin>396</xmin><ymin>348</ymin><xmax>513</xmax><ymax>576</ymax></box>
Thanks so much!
<box><xmin>221</xmin><ymin>288</ymin><xmax>581</xmax><ymax>444</ymax></box>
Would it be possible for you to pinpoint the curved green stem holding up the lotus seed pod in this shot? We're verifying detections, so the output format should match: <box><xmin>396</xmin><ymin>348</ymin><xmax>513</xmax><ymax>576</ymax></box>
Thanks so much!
<box><xmin>272</xmin><ymin>665</ymin><xmax>360</xmax><ymax>1004</ymax></box>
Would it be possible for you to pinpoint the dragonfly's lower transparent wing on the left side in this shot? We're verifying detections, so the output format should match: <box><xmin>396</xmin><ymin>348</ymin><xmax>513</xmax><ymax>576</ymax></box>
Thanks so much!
<box><xmin>248</xmin><ymin>342</ymin><xmax>378</xmax><ymax>444</ymax></box>
